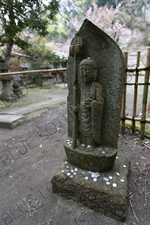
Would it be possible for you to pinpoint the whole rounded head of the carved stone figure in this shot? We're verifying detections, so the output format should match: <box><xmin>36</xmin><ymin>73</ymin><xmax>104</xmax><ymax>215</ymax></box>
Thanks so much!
<box><xmin>80</xmin><ymin>58</ymin><xmax>97</xmax><ymax>83</ymax></box>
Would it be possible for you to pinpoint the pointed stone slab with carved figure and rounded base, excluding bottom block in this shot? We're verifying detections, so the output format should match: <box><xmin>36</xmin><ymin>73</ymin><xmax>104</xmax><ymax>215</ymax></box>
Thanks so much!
<box><xmin>63</xmin><ymin>20</ymin><xmax>124</xmax><ymax>172</ymax></box>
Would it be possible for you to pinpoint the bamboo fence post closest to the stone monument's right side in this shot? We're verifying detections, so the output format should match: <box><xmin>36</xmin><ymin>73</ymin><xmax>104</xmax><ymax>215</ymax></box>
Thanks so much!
<box><xmin>121</xmin><ymin>52</ymin><xmax>128</xmax><ymax>135</ymax></box>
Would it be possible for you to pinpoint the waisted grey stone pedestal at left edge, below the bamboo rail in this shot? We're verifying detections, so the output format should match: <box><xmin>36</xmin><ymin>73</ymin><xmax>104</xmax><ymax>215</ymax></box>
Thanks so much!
<box><xmin>0</xmin><ymin>76</ymin><xmax>15</xmax><ymax>101</ymax></box>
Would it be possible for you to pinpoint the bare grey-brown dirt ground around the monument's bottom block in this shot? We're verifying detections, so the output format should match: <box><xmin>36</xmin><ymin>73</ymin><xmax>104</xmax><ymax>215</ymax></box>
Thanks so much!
<box><xmin>0</xmin><ymin>105</ymin><xmax>150</xmax><ymax>225</ymax></box>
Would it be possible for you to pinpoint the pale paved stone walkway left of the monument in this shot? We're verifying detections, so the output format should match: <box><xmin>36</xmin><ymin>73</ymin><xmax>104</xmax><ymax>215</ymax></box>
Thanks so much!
<box><xmin>0</xmin><ymin>89</ymin><xmax>67</xmax><ymax>129</ymax></box>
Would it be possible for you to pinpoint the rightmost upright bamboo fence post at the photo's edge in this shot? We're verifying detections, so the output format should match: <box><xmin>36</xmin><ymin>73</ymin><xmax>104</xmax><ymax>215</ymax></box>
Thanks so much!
<box><xmin>140</xmin><ymin>48</ymin><xmax>150</xmax><ymax>140</ymax></box>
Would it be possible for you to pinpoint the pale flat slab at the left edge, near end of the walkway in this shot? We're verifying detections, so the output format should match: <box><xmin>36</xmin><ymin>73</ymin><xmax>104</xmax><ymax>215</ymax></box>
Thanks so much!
<box><xmin>0</xmin><ymin>114</ymin><xmax>24</xmax><ymax>129</ymax></box>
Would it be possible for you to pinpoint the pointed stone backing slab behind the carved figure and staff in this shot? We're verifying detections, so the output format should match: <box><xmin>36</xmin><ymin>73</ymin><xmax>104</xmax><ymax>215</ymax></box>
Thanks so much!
<box><xmin>67</xmin><ymin>20</ymin><xmax>125</xmax><ymax>148</ymax></box>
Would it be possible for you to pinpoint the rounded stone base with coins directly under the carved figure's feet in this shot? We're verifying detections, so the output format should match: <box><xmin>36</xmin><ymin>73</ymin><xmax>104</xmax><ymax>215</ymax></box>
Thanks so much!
<box><xmin>63</xmin><ymin>138</ymin><xmax>118</xmax><ymax>172</ymax></box>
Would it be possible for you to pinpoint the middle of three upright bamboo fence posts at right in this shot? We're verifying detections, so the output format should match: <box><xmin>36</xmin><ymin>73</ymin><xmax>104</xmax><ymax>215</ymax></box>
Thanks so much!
<box><xmin>132</xmin><ymin>52</ymin><xmax>141</xmax><ymax>133</ymax></box>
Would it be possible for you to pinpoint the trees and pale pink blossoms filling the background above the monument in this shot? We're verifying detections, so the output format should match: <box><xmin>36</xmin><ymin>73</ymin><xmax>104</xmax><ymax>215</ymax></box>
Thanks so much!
<box><xmin>0</xmin><ymin>0</ymin><xmax>150</xmax><ymax>68</ymax></box>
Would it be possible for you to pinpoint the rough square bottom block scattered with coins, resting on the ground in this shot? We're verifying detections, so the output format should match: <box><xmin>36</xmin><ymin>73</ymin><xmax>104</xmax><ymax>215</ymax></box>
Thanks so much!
<box><xmin>51</xmin><ymin>153</ymin><xmax>130</xmax><ymax>221</ymax></box>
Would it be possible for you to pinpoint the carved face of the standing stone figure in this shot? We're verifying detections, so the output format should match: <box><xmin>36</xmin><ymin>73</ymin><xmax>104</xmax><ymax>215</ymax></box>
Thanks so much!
<box><xmin>80</xmin><ymin>65</ymin><xmax>94</xmax><ymax>83</ymax></box>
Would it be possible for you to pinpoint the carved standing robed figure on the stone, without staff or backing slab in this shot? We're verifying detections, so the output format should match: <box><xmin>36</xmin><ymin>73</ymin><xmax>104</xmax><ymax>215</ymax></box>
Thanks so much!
<box><xmin>78</xmin><ymin>58</ymin><xmax>104</xmax><ymax>151</ymax></box>
